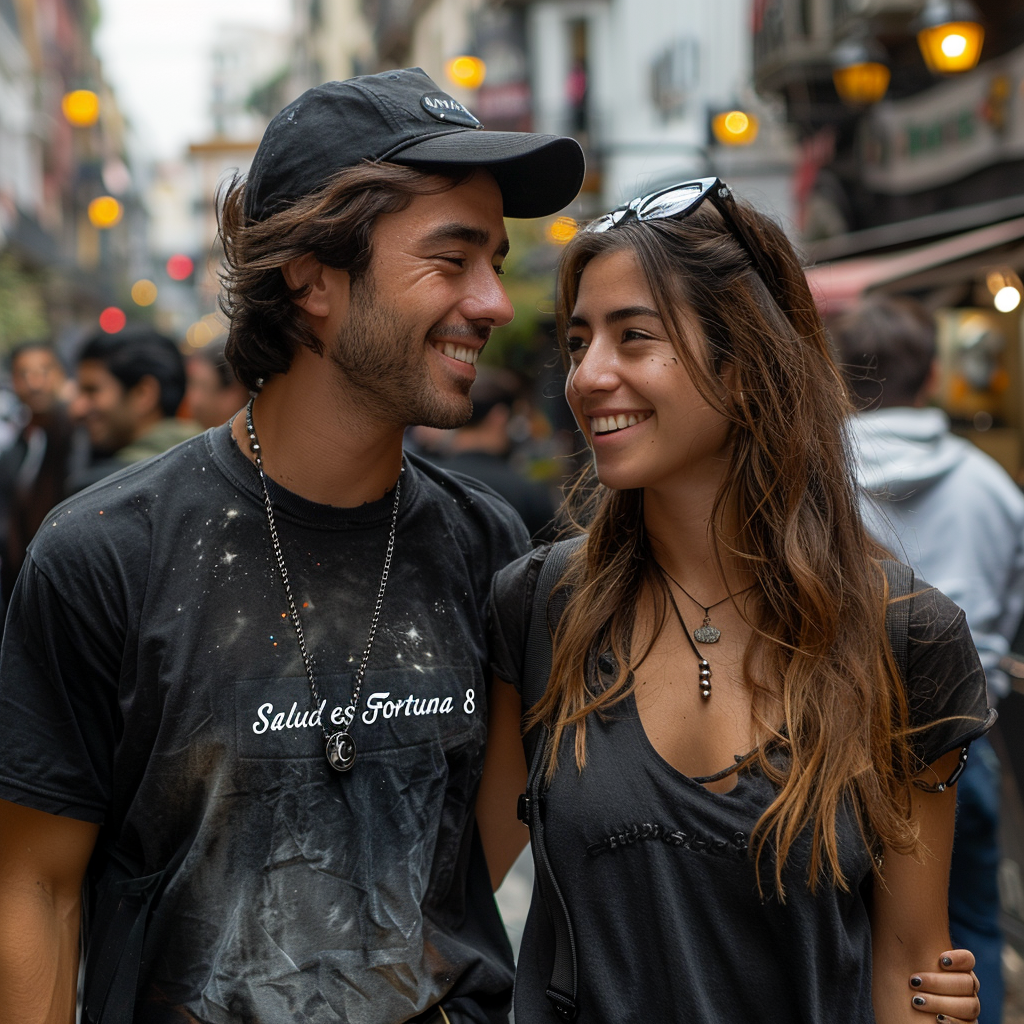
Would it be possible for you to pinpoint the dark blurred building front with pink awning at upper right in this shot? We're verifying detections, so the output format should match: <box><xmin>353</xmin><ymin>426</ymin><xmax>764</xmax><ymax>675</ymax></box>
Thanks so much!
<box><xmin>754</xmin><ymin>0</ymin><xmax>1024</xmax><ymax>477</ymax></box>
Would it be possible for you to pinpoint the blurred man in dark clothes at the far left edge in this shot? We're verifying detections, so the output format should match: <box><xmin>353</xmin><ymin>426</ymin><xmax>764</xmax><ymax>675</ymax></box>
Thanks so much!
<box><xmin>0</xmin><ymin>341</ymin><xmax>88</xmax><ymax>602</ymax></box>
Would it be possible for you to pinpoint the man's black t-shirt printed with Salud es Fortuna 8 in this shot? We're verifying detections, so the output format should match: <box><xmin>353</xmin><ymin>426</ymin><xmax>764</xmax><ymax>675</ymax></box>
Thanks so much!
<box><xmin>0</xmin><ymin>427</ymin><xmax>527</xmax><ymax>1024</ymax></box>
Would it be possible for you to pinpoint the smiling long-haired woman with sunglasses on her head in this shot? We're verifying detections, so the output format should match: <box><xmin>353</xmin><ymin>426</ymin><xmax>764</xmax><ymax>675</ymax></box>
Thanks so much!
<box><xmin>478</xmin><ymin>179</ymin><xmax>990</xmax><ymax>1024</ymax></box>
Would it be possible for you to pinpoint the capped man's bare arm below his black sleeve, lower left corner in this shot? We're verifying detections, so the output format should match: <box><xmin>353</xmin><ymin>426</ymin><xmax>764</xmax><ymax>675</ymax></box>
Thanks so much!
<box><xmin>0</xmin><ymin>800</ymin><xmax>99</xmax><ymax>1024</ymax></box>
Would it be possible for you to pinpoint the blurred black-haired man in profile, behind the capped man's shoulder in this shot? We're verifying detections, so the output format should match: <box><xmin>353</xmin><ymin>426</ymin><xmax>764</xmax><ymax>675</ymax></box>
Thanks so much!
<box><xmin>71</xmin><ymin>327</ymin><xmax>197</xmax><ymax>492</ymax></box>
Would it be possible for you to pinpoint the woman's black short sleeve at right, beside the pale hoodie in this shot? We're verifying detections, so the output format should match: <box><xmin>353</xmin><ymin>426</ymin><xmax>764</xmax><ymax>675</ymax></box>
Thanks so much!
<box><xmin>906</xmin><ymin>580</ymin><xmax>995</xmax><ymax>764</ymax></box>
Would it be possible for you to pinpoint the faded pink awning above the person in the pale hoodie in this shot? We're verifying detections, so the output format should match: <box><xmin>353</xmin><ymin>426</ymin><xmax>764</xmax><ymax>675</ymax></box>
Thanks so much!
<box><xmin>807</xmin><ymin>211</ymin><xmax>1024</xmax><ymax>314</ymax></box>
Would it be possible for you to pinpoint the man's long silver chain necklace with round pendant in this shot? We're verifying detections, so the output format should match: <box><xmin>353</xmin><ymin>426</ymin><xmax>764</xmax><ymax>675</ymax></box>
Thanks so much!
<box><xmin>246</xmin><ymin>395</ymin><xmax>406</xmax><ymax>771</ymax></box>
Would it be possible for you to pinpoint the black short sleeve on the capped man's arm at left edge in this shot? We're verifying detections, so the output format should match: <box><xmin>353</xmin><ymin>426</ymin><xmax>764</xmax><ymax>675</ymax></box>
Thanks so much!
<box><xmin>0</xmin><ymin>554</ymin><xmax>120</xmax><ymax>823</ymax></box>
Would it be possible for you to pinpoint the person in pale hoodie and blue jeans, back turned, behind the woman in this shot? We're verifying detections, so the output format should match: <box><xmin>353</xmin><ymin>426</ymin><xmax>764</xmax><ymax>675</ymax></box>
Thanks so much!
<box><xmin>831</xmin><ymin>297</ymin><xmax>1024</xmax><ymax>1024</ymax></box>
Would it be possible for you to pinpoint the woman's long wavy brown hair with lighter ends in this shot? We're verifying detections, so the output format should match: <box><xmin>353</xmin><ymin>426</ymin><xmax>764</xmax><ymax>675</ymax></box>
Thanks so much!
<box><xmin>526</xmin><ymin>204</ymin><xmax>923</xmax><ymax>898</ymax></box>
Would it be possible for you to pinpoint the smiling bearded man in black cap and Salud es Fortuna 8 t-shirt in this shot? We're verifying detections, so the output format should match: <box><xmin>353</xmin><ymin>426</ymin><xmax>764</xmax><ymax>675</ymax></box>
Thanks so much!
<box><xmin>0</xmin><ymin>69</ymin><xmax>584</xmax><ymax>1024</ymax></box>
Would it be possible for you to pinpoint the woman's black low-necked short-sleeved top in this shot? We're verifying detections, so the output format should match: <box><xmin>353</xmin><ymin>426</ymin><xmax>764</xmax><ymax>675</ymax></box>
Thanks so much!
<box><xmin>492</xmin><ymin>549</ymin><xmax>991</xmax><ymax>1024</ymax></box>
